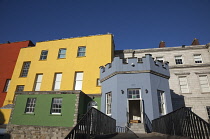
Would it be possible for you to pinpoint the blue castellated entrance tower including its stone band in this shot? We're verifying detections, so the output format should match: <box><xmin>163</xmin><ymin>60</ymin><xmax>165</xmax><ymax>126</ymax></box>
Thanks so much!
<box><xmin>100</xmin><ymin>54</ymin><xmax>172</xmax><ymax>126</ymax></box>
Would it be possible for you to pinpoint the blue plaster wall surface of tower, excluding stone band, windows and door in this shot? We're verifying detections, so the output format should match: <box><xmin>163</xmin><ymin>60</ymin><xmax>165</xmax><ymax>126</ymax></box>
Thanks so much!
<box><xmin>101</xmin><ymin>55</ymin><xmax>172</xmax><ymax>126</ymax></box>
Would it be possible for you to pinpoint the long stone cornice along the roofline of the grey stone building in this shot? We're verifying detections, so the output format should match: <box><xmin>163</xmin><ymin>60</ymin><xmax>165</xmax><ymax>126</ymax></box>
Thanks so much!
<box><xmin>115</xmin><ymin>45</ymin><xmax>208</xmax><ymax>54</ymax></box>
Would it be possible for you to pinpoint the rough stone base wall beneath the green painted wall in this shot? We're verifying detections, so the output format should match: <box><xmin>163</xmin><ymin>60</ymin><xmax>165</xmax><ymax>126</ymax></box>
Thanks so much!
<box><xmin>7</xmin><ymin>125</ymin><xmax>72</xmax><ymax>139</ymax></box>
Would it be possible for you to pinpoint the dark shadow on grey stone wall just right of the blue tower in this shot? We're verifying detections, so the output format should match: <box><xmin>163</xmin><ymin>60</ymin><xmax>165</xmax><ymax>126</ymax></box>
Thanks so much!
<box><xmin>170</xmin><ymin>90</ymin><xmax>185</xmax><ymax>111</ymax></box>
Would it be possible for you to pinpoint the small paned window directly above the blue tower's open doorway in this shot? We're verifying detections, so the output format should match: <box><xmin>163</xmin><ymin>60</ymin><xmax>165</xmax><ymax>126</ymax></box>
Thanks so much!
<box><xmin>127</xmin><ymin>88</ymin><xmax>141</xmax><ymax>100</ymax></box>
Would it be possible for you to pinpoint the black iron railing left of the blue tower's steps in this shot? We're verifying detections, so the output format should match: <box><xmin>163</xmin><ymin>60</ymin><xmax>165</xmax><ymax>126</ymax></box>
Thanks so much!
<box><xmin>65</xmin><ymin>107</ymin><xmax>116</xmax><ymax>139</ymax></box>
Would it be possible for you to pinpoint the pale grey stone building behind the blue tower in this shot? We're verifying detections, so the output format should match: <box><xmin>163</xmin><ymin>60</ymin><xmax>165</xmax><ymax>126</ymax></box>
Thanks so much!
<box><xmin>115</xmin><ymin>39</ymin><xmax>210</xmax><ymax>121</ymax></box>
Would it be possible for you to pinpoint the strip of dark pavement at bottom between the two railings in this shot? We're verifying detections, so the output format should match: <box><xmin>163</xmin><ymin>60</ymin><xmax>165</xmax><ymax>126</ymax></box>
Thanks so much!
<box><xmin>111</xmin><ymin>132</ymin><xmax>190</xmax><ymax>139</ymax></box>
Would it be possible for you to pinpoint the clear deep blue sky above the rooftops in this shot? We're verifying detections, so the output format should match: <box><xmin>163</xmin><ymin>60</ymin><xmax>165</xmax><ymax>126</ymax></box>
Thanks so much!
<box><xmin>0</xmin><ymin>0</ymin><xmax>210</xmax><ymax>50</ymax></box>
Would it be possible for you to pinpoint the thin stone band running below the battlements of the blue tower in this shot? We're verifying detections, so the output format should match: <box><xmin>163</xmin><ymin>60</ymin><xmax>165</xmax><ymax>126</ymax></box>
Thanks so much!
<box><xmin>100</xmin><ymin>70</ymin><xmax>170</xmax><ymax>82</ymax></box>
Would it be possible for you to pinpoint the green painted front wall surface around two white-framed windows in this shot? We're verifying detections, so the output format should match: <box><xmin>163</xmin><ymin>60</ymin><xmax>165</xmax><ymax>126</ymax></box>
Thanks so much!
<box><xmin>11</xmin><ymin>94</ymin><xmax>76</xmax><ymax>127</ymax></box>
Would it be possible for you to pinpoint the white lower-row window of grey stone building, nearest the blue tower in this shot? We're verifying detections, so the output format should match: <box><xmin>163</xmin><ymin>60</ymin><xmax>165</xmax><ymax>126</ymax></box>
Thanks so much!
<box><xmin>178</xmin><ymin>76</ymin><xmax>190</xmax><ymax>93</ymax></box>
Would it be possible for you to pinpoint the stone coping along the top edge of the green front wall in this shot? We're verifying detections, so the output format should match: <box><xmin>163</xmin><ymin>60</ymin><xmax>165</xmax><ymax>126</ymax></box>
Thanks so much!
<box><xmin>15</xmin><ymin>90</ymin><xmax>82</xmax><ymax>95</ymax></box>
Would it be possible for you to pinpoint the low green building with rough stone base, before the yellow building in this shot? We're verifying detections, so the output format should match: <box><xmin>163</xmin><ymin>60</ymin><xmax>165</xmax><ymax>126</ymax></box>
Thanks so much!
<box><xmin>7</xmin><ymin>90</ymin><xmax>97</xmax><ymax>138</ymax></box>
